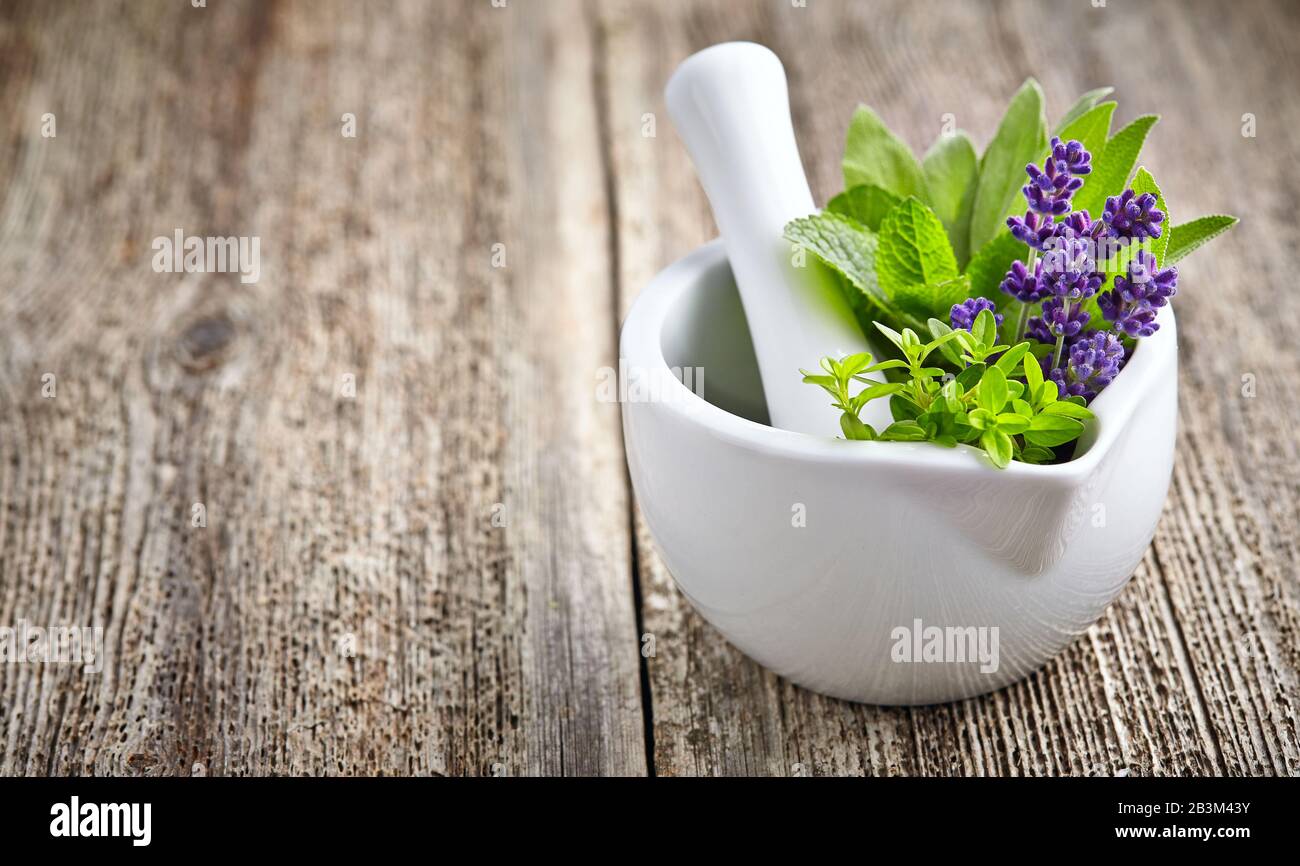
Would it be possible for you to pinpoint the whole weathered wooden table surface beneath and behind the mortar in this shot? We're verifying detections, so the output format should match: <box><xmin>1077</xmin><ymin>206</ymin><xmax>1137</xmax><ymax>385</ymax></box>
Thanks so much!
<box><xmin>0</xmin><ymin>0</ymin><xmax>1300</xmax><ymax>775</ymax></box>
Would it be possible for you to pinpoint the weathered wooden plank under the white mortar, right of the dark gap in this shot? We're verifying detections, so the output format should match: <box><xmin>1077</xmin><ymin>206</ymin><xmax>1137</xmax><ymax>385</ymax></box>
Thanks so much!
<box><xmin>601</xmin><ymin>3</ymin><xmax>1300</xmax><ymax>775</ymax></box>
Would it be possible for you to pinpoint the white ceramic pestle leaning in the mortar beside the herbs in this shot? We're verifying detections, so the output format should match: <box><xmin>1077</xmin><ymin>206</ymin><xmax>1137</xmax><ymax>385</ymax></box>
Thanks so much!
<box><xmin>664</xmin><ymin>42</ymin><xmax>889</xmax><ymax>436</ymax></box>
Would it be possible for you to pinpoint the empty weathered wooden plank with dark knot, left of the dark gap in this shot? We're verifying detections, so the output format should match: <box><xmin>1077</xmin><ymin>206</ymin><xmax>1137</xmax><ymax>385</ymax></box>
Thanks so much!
<box><xmin>0</xmin><ymin>1</ymin><xmax>646</xmax><ymax>775</ymax></box>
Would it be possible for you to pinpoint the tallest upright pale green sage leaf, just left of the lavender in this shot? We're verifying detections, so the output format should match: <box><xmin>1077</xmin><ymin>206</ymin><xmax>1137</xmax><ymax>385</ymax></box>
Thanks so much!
<box><xmin>969</xmin><ymin>78</ymin><xmax>1048</xmax><ymax>250</ymax></box>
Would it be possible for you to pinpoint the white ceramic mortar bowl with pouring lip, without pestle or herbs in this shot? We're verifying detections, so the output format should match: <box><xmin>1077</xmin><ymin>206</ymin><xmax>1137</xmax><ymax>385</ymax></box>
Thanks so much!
<box><xmin>620</xmin><ymin>241</ymin><xmax>1178</xmax><ymax>705</ymax></box>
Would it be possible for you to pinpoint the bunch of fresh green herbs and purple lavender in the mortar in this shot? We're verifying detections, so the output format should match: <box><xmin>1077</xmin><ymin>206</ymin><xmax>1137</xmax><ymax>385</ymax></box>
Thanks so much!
<box><xmin>785</xmin><ymin>79</ymin><xmax>1236</xmax><ymax>467</ymax></box>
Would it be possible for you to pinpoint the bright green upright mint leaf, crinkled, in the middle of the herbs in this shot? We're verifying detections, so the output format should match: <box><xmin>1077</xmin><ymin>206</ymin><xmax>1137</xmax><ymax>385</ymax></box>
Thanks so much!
<box><xmin>876</xmin><ymin>198</ymin><xmax>958</xmax><ymax>305</ymax></box>
